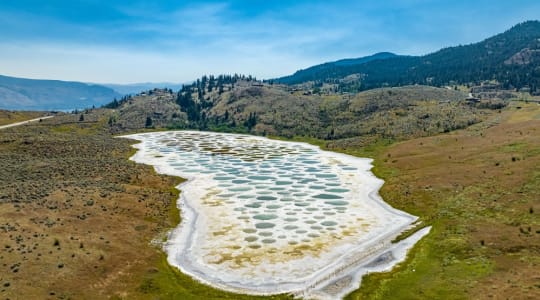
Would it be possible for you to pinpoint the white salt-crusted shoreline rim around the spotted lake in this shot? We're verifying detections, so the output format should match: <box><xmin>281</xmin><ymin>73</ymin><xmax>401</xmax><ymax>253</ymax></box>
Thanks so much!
<box><xmin>124</xmin><ymin>132</ymin><xmax>429</xmax><ymax>298</ymax></box>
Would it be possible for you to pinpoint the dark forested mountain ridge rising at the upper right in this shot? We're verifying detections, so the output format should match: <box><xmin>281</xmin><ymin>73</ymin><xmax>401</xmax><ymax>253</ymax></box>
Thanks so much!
<box><xmin>272</xmin><ymin>21</ymin><xmax>540</xmax><ymax>92</ymax></box>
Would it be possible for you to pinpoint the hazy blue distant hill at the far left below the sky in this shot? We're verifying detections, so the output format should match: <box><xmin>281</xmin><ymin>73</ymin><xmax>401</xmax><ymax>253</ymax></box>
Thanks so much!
<box><xmin>0</xmin><ymin>75</ymin><xmax>121</xmax><ymax>110</ymax></box>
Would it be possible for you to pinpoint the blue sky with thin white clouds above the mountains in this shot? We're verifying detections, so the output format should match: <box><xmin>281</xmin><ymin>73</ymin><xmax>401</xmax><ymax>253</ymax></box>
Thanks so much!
<box><xmin>0</xmin><ymin>0</ymin><xmax>540</xmax><ymax>83</ymax></box>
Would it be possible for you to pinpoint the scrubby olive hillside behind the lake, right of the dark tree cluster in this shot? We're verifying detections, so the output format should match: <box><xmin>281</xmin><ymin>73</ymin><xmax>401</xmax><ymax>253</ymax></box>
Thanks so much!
<box><xmin>208</xmin><ymin>86</ymin><xmax>476</xmax><ymax>145</ymax></box>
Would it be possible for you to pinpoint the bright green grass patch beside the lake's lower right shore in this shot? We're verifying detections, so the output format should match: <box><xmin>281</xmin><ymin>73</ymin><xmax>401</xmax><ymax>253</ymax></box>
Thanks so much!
<box><xmin>346</xmin><ymin>183</ymin><xmax>494</xmax><ymax>299</ymax></box>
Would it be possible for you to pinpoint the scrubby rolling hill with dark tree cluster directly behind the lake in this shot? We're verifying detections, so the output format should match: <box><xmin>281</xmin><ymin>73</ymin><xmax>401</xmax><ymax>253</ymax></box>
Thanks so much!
<box><xmin>106</xmin><ymin>76</ymin><xmax>498</xmax><ymax>149</ymax></box>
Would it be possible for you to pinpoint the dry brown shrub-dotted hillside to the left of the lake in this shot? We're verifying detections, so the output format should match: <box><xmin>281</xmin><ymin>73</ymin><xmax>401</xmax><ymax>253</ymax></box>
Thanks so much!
<box><xmin>0</xmin><ymin>110</ymin><xmax>292</xmax><ymax>299</ymax></box>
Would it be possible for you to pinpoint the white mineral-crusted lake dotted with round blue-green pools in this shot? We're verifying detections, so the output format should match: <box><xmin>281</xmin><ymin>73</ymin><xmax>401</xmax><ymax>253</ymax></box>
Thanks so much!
<box><xmin>125</xmin><ymin>131</ymin><xmax>422</xmax><ymax>294</ymax></box>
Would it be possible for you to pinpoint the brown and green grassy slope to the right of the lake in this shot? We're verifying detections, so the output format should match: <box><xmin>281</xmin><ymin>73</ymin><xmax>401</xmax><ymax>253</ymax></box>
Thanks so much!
<box><xmin>348</xmin><ymin>104</ymin><xmax>540</xmax><ymax>299</ymax></box>
